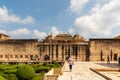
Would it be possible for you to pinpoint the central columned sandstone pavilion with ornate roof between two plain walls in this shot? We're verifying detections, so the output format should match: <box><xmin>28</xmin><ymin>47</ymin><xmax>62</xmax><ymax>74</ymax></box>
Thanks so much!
<box><xmin>39</xmin><ymin>33</ymin><xmax>89</xmax><ymax>61</ymax></box>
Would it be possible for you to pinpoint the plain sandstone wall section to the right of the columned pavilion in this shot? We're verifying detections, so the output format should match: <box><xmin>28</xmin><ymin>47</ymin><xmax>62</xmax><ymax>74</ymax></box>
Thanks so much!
<box><xmin>89</xmin><ymin>39</ymin><xmax>120</xmax><ymax>61</ymax></box>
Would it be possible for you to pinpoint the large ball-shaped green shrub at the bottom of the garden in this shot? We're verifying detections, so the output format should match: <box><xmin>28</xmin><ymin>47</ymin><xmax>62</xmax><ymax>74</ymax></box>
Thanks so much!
<box><xmin>16</xmin><ymin>65</ymin><xmax>35</xmax><ymax>80</ymax></box>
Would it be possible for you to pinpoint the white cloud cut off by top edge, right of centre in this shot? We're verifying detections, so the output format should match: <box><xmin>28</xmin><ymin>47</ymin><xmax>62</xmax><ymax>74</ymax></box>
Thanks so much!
<box><xmin>69</xmin><ymin>0</ymin><xmax>89</xmax><ymax>13</ymax></box>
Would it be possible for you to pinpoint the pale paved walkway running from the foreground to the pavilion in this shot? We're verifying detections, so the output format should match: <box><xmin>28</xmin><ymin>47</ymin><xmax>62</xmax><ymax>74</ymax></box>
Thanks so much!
<box><xmin>58</xmin><ymin>62</ymin><xmax>120</xmax><ymax>80</ymax></box>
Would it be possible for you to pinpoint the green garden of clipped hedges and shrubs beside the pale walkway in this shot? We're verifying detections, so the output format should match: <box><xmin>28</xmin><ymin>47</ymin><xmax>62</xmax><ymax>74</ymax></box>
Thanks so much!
<box><xmin>0</xmin><ymin>61</ymin><xmax>60</xmax><ymax>80</ymax></box>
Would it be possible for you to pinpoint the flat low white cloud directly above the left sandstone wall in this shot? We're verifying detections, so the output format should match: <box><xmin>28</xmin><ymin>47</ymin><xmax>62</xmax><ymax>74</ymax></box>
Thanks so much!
<box><xmin>8</xmin><ymin>28</ymin><xmax>31</xmax><ymax>37</ymax></box>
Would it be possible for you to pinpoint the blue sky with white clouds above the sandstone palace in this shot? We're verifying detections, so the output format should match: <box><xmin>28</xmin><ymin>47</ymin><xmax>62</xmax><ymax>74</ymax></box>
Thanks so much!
<box><xmin>0</xmin><ymin>0</ymin><xmax>120</xmax><ymax>39</ymax></box>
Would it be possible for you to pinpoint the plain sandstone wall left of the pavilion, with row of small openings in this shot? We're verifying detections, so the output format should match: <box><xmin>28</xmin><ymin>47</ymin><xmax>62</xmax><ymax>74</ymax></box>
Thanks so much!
<box><xmin>0</xmin><ymin>39</ymin><xmax>39</xmax><ymax>62</ymax></box>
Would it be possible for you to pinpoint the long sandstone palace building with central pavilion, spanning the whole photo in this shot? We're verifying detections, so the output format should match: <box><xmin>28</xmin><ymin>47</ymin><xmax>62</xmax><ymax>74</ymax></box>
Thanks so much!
<box><xmin>0</xmin><ymin>33</ymin><xmax>120</xmax><ymax>63</ymax></box>
